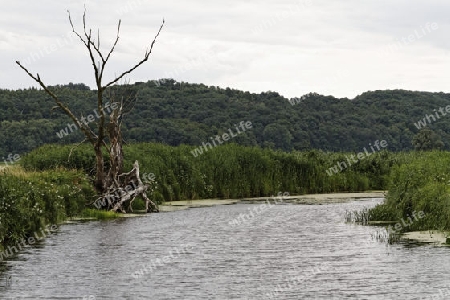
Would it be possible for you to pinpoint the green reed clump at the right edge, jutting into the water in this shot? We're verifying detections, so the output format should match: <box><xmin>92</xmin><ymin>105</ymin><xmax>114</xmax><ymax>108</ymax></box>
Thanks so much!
<box><xmin>370</xmin><ymin>151</ymin><xmax>450</xmax><ymax>231</ymax></box>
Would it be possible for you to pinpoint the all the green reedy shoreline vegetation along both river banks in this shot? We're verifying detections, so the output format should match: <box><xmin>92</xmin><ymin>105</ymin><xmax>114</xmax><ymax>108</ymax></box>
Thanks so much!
<box><xmin>0</xmin><ymin>143</ymin><xmax>450</xmax><ymax>249</ymax></box>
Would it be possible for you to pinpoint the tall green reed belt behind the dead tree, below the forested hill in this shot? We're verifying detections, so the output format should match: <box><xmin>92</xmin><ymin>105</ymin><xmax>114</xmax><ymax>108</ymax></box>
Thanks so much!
<box><xmin>22</xmin><ymin>143</ymin><xmax>401</xmax><ymax>203</ymax></box>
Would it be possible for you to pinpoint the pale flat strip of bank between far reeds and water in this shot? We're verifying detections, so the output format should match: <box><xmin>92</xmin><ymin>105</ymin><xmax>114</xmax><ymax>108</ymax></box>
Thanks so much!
<box><xmin>159</xmin><ymin>191</ymin><xmax>385</xmax><ymax>212</ymax></box>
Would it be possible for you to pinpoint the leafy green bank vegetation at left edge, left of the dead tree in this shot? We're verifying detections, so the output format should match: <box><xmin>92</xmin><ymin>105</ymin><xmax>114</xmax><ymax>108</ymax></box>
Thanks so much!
<box><xmin>0</xmin><ymin>167</ymin><xmax>94</xmax><ymax>250</ymax></box>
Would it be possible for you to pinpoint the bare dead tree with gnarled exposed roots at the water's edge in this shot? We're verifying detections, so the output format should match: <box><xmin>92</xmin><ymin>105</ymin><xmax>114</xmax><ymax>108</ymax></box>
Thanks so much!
<box><xmin>16</xmin><ymin>11</ymin><xmax>164</xmax><ymax>212</ymax></box>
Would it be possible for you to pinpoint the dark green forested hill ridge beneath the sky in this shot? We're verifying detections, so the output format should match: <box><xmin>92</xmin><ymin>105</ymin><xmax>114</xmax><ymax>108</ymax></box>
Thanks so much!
<box><xmin>0</xmin><ymin>80</ymin><xmax>450</xmax><ymax>155</ymax></box>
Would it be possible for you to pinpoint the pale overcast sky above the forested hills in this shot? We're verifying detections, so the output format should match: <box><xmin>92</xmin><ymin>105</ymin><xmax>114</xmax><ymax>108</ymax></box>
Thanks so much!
<box><xmin>0</xmin><ymin>0</ymin><xmax>450</xmax><ymax>98</ymax></box>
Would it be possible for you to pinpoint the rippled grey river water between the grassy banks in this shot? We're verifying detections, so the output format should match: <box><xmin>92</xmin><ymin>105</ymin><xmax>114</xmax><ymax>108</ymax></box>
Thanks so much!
<box><xmin>0</xmin><ymin>199</ymin><xmax>450</xmax><ymax>300</ymax></box>
